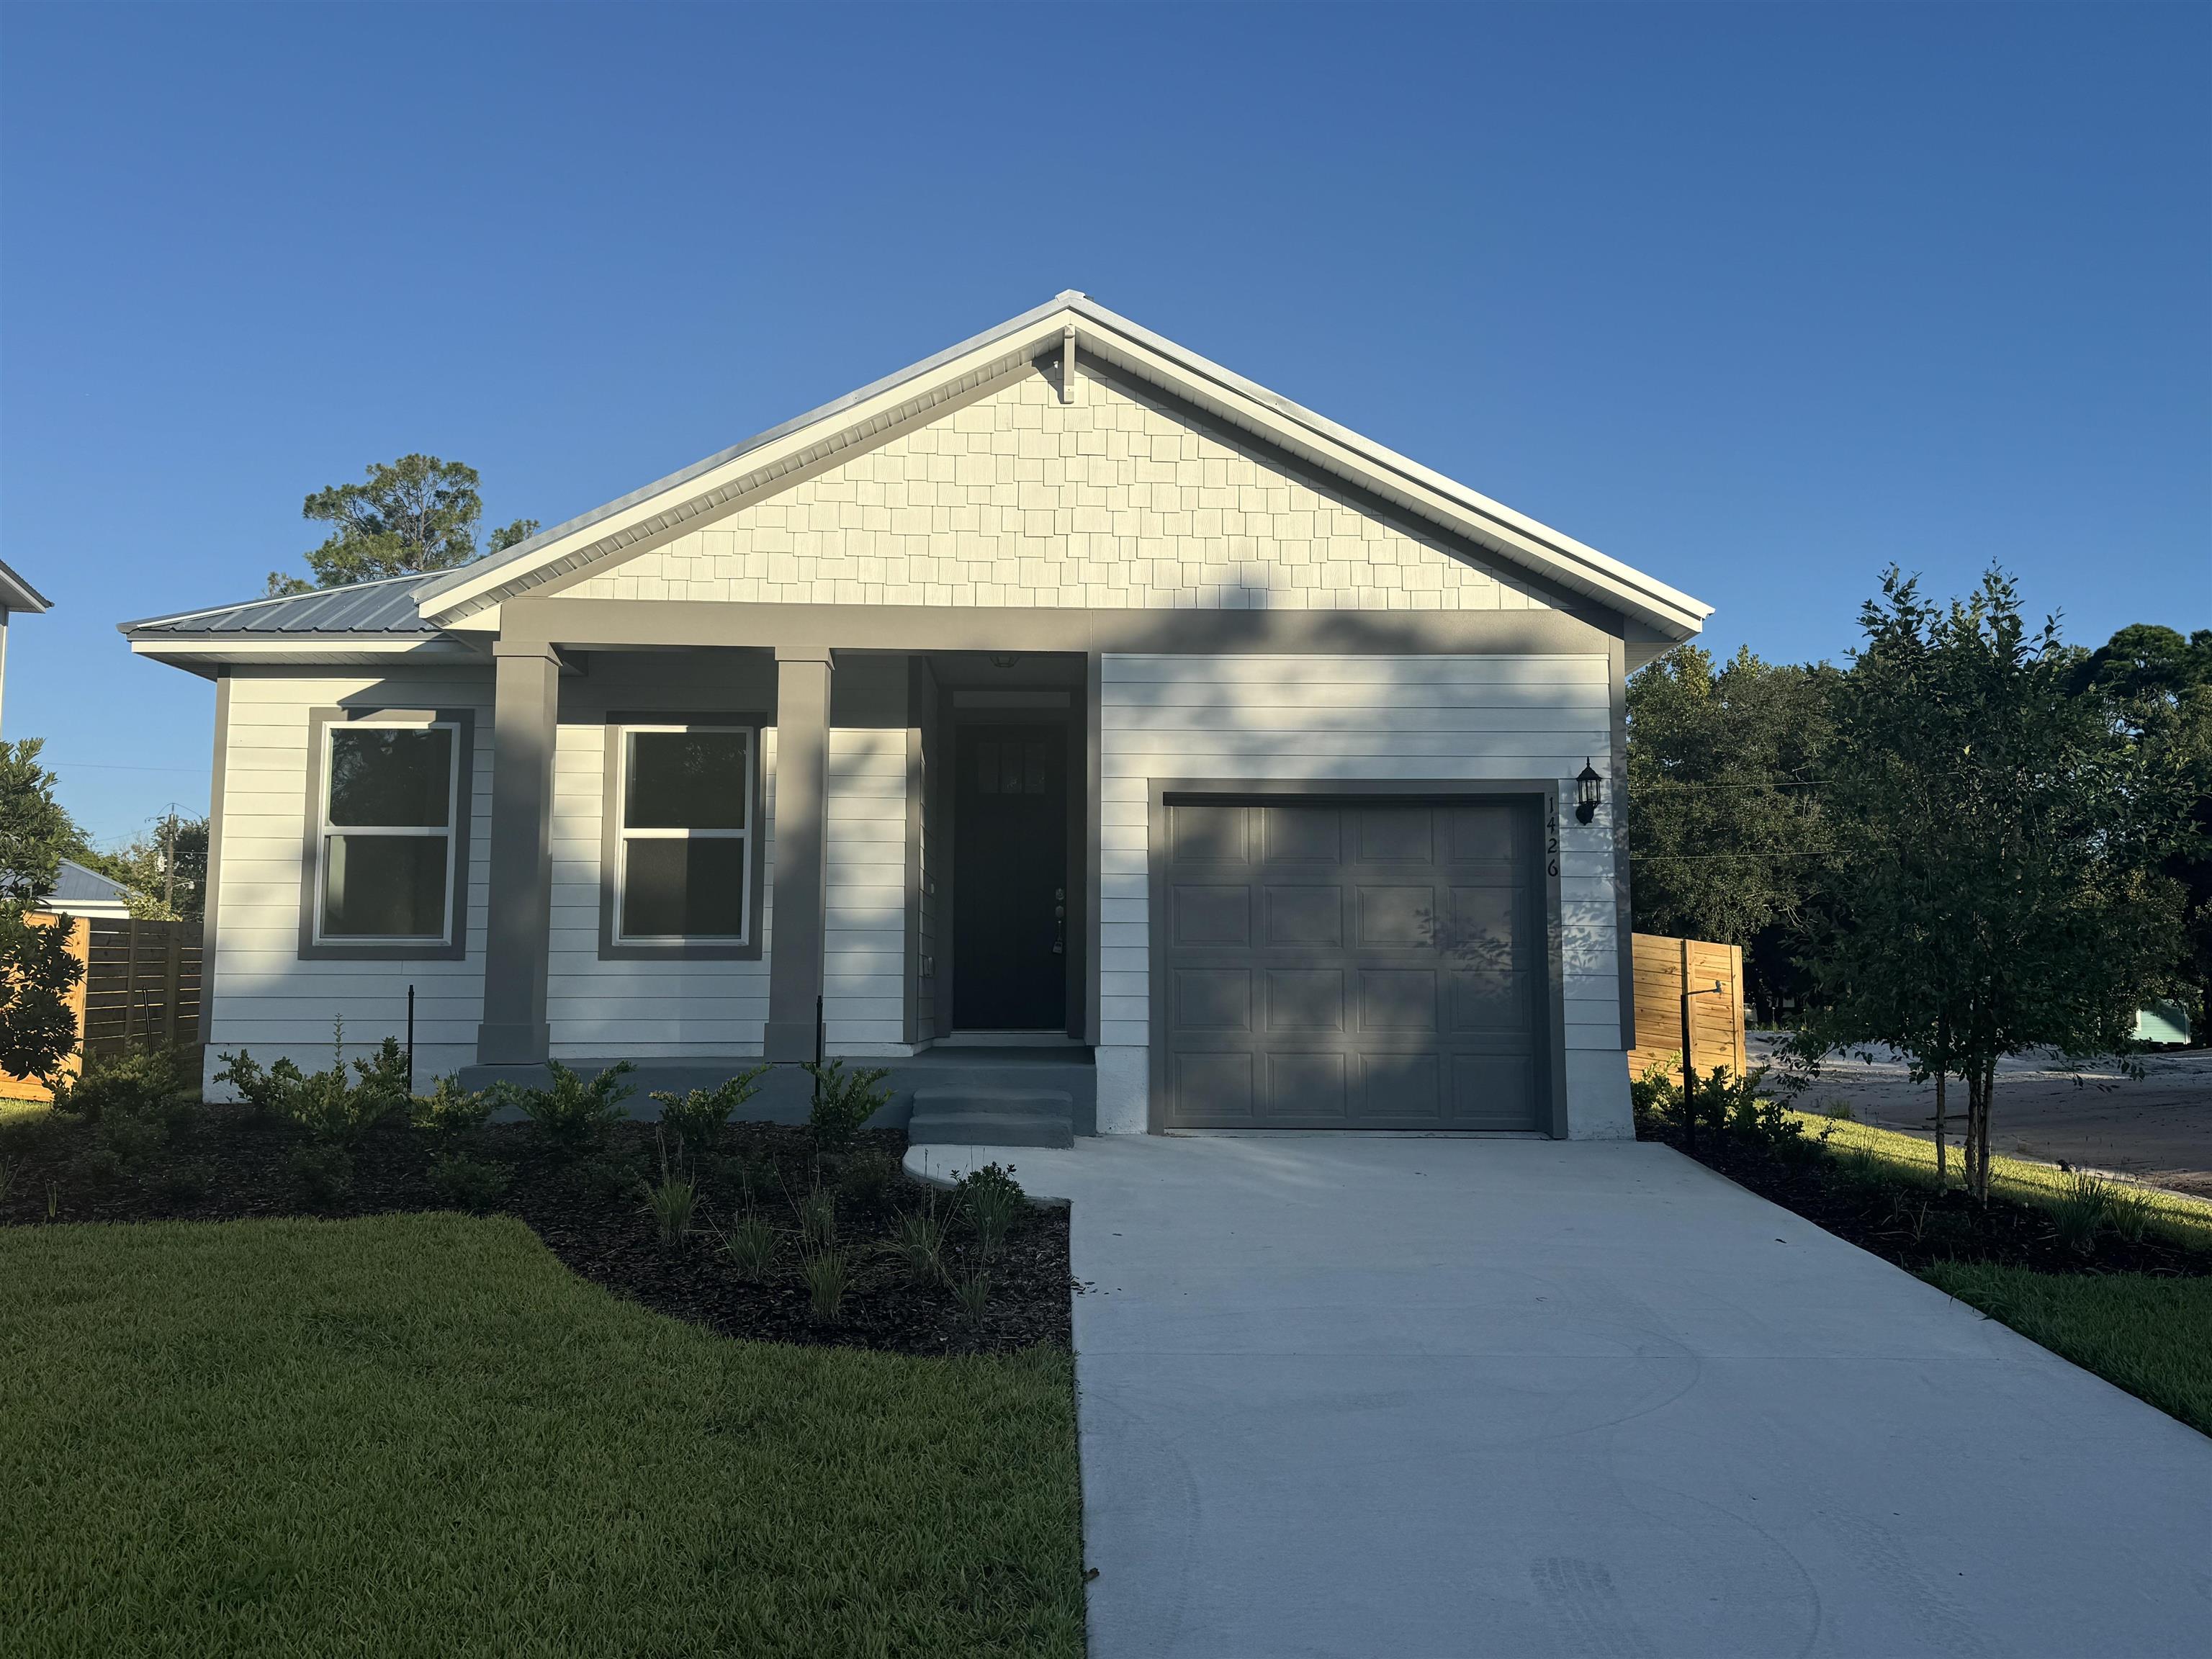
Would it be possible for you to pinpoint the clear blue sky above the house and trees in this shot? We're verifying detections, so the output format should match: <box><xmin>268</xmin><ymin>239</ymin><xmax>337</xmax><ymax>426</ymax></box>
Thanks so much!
<box><xmin>0</xmin><ymin>4</ymin><xmax>2212</xmax><ymax>838</ymax></box>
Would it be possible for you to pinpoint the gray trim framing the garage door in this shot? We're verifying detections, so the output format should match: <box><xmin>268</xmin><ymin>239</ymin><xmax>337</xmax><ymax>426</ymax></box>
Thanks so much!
<box><xmin>1146</xmin><ymin>778</ymin><xmax>1566</xmax><ymax>1141</ymax></box>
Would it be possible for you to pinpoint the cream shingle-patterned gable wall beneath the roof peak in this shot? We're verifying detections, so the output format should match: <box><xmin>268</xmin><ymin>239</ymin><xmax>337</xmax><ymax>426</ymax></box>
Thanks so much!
<box><xmin>571</xmin><ymin>372</ymin><xmax>1544</xmax><ymax>611</ymax></box>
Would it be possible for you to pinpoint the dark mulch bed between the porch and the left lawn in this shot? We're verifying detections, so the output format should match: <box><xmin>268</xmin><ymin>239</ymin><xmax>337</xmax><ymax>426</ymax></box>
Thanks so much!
<box><xmin>0</xmin><ymin>1106</ymin><xmax>1073</xmax><ymax>1354</ymax></box>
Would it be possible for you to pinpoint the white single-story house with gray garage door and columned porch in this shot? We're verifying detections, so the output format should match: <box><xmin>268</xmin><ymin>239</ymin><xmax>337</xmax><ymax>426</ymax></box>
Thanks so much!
<box><xmin>124</xmin><ymin>295</ymin><xmax>1710</xmax><ymax>1139</ymax></box>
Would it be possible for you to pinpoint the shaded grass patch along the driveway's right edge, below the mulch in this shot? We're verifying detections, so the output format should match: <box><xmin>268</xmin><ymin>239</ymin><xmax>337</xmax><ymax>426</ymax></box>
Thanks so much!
<box><xmin>1923</xmin><ymin>1261</ymin><xmax>2212</xmax><ymax>1434</ymax></box>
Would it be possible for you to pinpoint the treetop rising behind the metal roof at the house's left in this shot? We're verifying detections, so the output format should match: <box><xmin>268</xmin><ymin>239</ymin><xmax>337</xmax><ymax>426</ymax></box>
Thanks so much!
<box><xmin>268</xmin><ymin>456</ymin><xmax>537</xmax><ymax>597</ymax></box>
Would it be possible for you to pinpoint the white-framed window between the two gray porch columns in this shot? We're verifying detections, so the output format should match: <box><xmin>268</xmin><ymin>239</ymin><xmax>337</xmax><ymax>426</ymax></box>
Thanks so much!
<box><xmin>613</xmin><ymin>726</ymin><xmax>755</xmax><ymax>945</ymax></box>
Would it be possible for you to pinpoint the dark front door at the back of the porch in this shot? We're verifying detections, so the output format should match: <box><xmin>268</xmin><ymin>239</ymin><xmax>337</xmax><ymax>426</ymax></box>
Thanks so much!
<box><xmin>953</xmin><ymin>724</ymin><xmax>1069</xmax><ymax>1031</ymax></box>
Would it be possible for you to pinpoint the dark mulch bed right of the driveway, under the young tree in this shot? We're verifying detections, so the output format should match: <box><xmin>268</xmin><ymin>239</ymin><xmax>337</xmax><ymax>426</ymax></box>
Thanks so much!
<box><xmin>1637</xmin><ymin>1112</ymin><xmax>2212</xmax><ymax>1279</ymax></box>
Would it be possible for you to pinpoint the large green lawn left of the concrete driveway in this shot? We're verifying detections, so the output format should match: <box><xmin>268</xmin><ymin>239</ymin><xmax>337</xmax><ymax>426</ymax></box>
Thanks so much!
<box><xmin>0</xmin><ymin>1215</ymin><xmax>1084</xmax><ymax>1657</ymax></box>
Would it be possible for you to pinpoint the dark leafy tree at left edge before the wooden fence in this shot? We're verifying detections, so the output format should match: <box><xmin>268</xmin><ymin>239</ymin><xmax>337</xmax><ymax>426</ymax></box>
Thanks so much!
<box><xmin>0</xmin><ymin>739</ymin><xmax>84</xmax><ymax>1084</ymax></box>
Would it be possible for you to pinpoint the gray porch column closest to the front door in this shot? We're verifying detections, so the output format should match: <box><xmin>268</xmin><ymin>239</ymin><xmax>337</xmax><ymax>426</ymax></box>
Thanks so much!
<box><xmin>763</xmin><ymin>646</ymin><xmax>830</xmax><ymax>1062</ymax></box>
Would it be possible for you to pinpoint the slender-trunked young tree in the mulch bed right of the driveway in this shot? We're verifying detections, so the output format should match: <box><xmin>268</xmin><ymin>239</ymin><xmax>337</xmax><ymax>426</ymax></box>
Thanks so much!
<box><xmin>1799</xmin><ymin>569</ymin><xmax>2181</xmax><ymax>1199</ymax></box>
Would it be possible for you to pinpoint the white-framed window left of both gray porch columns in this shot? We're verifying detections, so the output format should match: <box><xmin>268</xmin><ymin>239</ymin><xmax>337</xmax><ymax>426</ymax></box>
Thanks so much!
<box><xmin>314</xmin><ymin>719</ymin><xmax>464</xmax><ymax>945</ymax></box>
